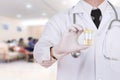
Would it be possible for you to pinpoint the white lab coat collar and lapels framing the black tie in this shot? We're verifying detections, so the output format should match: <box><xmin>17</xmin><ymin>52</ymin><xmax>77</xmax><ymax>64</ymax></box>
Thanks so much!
<box><xmin>72</xmin><ymin>0</ymin><xmax>114</xmax><ymax>32</ymax></box>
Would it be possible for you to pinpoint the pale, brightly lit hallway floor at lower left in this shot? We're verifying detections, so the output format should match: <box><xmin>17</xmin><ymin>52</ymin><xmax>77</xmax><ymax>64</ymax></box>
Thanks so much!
<box><xmin>0</xmin><ymin>60</ymin><xmax>56</xmax><ymax>80</ymax></box>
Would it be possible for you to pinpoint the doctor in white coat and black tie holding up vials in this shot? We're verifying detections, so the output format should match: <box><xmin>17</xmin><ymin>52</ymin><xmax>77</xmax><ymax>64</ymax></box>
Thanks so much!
<box><xmin>34</xmin><ymin>0</ymin><xmax>120</xmax><ymax>80</ymax></box>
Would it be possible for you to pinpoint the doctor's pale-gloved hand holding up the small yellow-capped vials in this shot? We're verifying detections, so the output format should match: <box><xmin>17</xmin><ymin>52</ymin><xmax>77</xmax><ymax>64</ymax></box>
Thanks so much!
<box><xmin>51</xmin><ymin>25</ymin><xmax>88</xmax><ymax>59</ymax></box>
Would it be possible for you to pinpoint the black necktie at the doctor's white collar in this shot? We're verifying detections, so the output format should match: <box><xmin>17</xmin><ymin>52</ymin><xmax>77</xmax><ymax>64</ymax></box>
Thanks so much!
<box><xmin>91</xmin><ymin>9</ymin><xmax>102</xmax><ymax>28</ymax></box>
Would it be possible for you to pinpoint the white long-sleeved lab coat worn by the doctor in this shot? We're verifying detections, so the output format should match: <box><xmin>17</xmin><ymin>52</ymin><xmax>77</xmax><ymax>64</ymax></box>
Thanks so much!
<box><xmin>34</xmin><ymin>0</ymin><xmax>120</xmax><ymax>80</ymax></box>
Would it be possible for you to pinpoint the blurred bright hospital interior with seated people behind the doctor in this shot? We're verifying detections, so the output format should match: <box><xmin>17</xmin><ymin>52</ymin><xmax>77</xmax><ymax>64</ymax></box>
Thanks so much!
<box><xmin>0</xmin><ymin>0</ymin><xmax>120</xmax><ymax>80</ymax></box>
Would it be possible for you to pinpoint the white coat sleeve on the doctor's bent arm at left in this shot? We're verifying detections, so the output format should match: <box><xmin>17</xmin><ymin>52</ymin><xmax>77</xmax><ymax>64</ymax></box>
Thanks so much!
<box><xmin>33</xmin><ymin>17</ymin><xmax>62</xmax><ymax>64</ymax></box>
